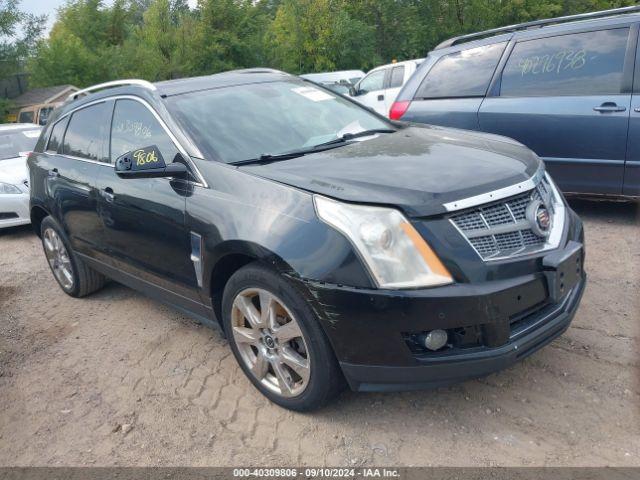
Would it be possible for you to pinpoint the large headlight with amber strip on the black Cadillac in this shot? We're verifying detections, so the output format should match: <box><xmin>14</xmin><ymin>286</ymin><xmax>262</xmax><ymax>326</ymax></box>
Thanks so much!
<box><xmin>313</xmin><ymin>195</ymin><xmax>453</xmax><ymax>288</ymax></box>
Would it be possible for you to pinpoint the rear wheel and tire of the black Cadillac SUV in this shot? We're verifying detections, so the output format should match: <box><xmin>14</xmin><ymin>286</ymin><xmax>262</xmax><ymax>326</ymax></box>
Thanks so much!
<box><xmin>40</xmin><ymin>217</ymin><xmax>107</xmax><ymax>298</ymax></box>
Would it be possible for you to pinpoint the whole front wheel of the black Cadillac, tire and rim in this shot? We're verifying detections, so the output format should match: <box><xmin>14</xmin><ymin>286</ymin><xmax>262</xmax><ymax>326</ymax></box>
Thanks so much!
<box><xmin>222</xmin><ymin>263</ymin><xmax>345</xmax><ymax>411</ymax></box>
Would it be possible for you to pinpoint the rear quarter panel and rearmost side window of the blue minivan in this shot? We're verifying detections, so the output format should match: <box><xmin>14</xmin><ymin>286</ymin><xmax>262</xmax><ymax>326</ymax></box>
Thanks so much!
<box><xmin>402</xmin><ymin>42</ymin><xmax>506</xmax><ymax>130</ymax></box>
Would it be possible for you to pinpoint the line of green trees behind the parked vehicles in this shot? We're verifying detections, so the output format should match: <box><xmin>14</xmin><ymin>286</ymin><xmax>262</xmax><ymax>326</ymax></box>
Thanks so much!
<box><xmin>0</xmin><ymin>0</ymin><xmax>635</xmax><ymax>87</ymax></box>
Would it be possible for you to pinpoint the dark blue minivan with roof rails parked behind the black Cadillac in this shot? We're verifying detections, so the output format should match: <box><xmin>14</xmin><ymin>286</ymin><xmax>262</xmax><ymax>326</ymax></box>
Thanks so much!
<box><xmin>390</xmin><ymin>7</ymin><xmax>640</xmax><ymax>197</ymax></box>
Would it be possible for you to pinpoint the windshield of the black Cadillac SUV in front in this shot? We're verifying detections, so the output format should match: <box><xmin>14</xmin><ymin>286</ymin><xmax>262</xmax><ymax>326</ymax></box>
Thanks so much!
<box><xmin>168</xmin><ymin>79</ymin><xmax>391</xmax><ymax>163</ymax></box>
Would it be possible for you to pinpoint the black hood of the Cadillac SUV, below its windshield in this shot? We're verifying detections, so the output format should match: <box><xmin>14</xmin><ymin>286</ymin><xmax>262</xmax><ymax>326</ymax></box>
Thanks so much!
<box><xmin>239</xmin><ymin>126</ymin><xmax>542</xmax><ymax>216</ymax></box>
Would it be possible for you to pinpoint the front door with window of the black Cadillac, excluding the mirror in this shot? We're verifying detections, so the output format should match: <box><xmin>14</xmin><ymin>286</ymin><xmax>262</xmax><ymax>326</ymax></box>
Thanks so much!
<box><xmin>97</xmin><ymin>99</ymin><xmax>200</xmax><ymax>308</ymax></box>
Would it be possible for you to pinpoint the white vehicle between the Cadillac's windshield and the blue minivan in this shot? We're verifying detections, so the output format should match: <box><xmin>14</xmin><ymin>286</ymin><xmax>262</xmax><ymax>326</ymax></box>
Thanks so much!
<box><xmin>349</xmin><ymin>58</ymin><xmax>424</xmax><ymax>117</ymax></box>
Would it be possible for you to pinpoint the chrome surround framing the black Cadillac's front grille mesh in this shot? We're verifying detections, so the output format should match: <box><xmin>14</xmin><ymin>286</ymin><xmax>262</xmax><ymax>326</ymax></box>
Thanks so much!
<box><xmin>449</xmin><ymin>169</ymin><xmax>567</xmax><ymax>263</ymax></box>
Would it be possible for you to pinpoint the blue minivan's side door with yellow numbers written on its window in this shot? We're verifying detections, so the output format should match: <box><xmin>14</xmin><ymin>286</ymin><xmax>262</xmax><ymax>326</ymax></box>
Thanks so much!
<box><xmin>479</xmin><ymin>26</ymin><xmax>635</xmax><ymax>194</ymax></box>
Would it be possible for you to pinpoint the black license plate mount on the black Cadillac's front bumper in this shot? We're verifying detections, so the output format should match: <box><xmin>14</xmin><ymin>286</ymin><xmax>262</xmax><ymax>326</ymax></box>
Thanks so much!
<box><xmin>542</xmin><ymin>241</ymin><xmax>584</xmax><ymax>302</ymax></box>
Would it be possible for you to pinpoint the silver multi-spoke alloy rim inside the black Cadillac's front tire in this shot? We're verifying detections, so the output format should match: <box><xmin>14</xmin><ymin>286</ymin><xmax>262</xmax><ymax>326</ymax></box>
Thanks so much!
<box><xmin>231</xmin><ymin>288</ymin><xmax>311</xmax><ymax>397</ymax></box>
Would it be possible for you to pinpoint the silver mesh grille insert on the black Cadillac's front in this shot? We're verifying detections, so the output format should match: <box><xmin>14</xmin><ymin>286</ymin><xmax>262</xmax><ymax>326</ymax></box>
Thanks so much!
<box><xmin>449</xmin><ymin>178</ymin><xmax>555</xmax><ymax>260</ymax></box>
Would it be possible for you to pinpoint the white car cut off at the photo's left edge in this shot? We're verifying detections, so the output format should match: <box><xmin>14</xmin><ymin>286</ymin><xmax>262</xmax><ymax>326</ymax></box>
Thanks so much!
<box><xmin>0</xmin><ymin>123</ymin><xmax>41</xmax><ymax>228</ymax></box>
